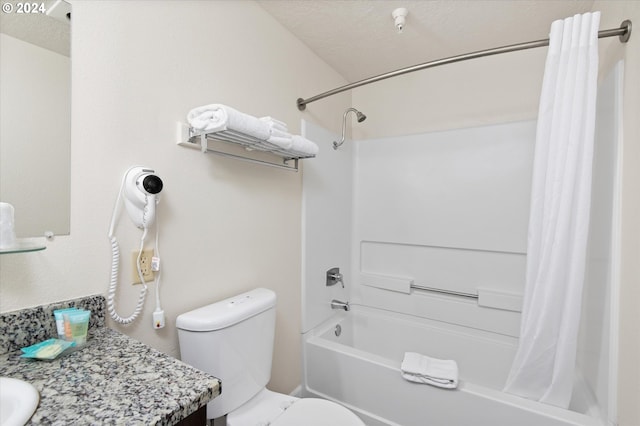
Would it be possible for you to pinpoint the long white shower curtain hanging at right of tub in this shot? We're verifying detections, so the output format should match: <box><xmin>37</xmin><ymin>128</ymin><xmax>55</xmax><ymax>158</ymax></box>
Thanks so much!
<box><xmin>505</xmin><ymin>12</ymin><xmax>600</xmax><ymax>408</ymax></box>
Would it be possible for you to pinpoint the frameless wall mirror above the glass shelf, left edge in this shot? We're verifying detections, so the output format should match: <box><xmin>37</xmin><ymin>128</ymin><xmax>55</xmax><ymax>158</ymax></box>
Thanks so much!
<box><xmin>0</xmin><ymin>0</ymin><xmax>71</xmax><ymax>238</ymax></box>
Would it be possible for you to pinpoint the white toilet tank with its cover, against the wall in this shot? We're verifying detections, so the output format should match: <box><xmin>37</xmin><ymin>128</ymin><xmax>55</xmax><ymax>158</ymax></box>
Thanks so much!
<box><xmin>176</xmin><ymin>288</ymin><xmax>276</xmax><ymax>419</ymax></box>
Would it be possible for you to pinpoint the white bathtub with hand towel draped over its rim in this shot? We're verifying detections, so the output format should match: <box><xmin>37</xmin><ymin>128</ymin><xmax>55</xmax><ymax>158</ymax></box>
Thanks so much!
<box><xmin>302</xmin><ymin>306</ymin><xmax>606</xmax><ymax>426</ymax></box>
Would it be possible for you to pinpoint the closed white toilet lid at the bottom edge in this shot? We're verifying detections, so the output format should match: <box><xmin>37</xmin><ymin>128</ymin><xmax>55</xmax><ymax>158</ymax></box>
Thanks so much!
<box><xmin>271</xmin><ymin>398</ymin><xmax>364</xmax><ymax>426</ymax></box>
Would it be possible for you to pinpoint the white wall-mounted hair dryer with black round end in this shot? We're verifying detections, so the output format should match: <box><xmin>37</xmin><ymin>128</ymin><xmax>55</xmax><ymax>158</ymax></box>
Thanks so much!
<box><xmin>123</xmin><ymin>166</ymin><xmax>162</xmax><ymax>229</ymax></box>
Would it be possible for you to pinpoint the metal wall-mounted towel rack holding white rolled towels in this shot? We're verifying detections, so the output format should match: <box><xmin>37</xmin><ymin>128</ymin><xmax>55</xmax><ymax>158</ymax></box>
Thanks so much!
<box><xmin>177</xmin><ymin>122</ymin><xmax>315</xmax><ymax>172</ymax></box>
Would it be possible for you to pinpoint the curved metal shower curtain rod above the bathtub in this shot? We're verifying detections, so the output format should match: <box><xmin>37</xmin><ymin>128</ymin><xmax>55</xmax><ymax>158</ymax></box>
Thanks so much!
<box><xmin>296</xmin><ymin>19</ymin><xmax>631</xmax><ymax>111</ymax></box>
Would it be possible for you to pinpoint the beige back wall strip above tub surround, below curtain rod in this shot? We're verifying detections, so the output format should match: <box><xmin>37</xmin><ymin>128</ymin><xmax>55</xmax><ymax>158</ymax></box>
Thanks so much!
<box><xmin>353</xmin><ymin>47</ymin><xmax>546</xmax><ymax>140</ymax></box>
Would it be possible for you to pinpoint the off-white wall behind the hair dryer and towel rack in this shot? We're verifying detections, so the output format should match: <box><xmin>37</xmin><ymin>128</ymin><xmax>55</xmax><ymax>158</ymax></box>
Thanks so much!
<box><xmin>0</xmin><ymin>1</ymin><xmax>348</xmax><ymax>392</ymax></box>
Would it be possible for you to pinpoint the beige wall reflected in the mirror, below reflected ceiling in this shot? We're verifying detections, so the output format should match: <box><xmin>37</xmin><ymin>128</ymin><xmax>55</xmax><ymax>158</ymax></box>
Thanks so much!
<box><xmin>0</xmin><ymin>34</ymin><xmax>71</xmax><ymax>238</ymax></box>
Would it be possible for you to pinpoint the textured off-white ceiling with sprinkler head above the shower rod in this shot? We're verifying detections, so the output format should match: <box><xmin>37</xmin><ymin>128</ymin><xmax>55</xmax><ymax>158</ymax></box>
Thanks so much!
<box><xmin>258</xmin><ymin>0</ymin><xmax>593</xmax><ymax>82</ymax></box>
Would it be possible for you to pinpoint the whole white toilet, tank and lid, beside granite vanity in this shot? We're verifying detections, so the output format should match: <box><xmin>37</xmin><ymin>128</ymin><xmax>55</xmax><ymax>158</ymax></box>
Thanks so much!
<box><xmin>176</xmin><ymin>288</ymin><xmax>364</xmax><ymax>426</ymax></box>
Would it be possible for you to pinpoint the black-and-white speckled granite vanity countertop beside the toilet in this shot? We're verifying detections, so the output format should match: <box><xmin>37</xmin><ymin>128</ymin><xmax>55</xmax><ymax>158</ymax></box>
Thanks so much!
<box><xmin>0</xmin><ymin>296</ymin><xmax>220</xmax><ymax>425</ymax></box>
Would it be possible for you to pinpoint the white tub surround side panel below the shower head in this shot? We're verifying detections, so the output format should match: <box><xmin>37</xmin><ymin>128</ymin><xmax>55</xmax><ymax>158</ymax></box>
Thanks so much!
<box><xmin>302</xmin><ymin>122</ymin><xmax>354</xmax><ymax>333</ymax></box>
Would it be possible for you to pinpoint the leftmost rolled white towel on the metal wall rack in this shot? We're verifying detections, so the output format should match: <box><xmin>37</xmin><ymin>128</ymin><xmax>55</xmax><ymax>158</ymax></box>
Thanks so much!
<box><xmin>187</xmin><ymin>104</ymin><xmax>271</xmax><ymax>141</ymax></box>
